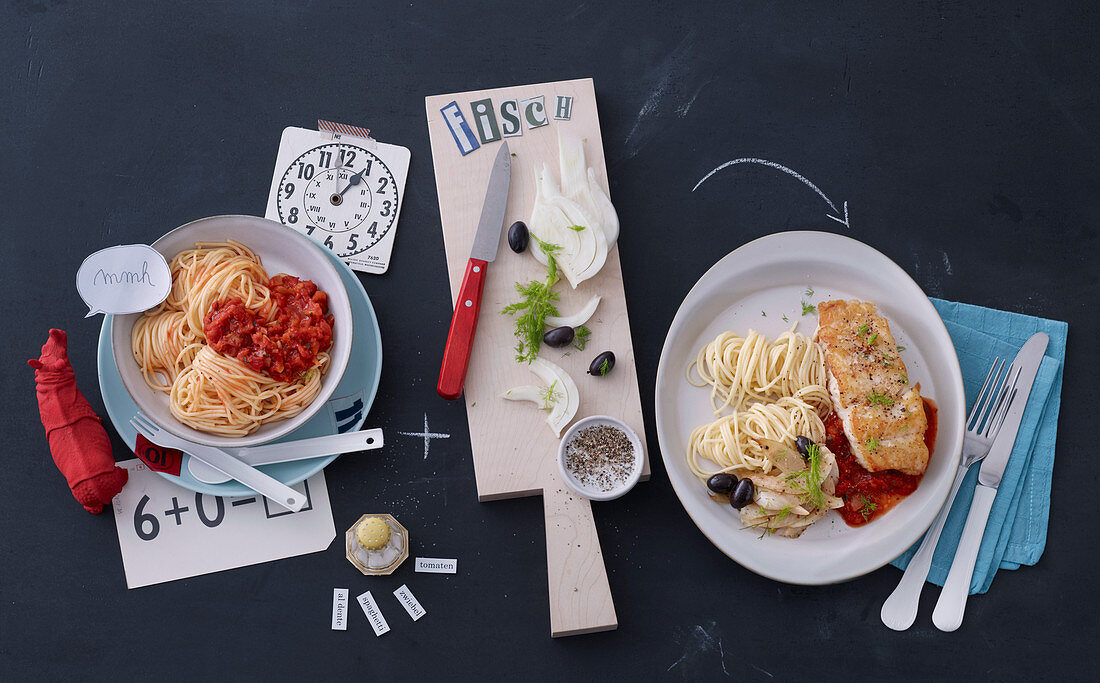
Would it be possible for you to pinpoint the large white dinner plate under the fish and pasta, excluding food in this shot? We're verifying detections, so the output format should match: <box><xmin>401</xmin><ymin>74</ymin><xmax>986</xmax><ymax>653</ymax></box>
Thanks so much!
<box><xmin>656</xmin><ymin>232</ymin><xmax>965</xmax><ymax>584</ymax></box>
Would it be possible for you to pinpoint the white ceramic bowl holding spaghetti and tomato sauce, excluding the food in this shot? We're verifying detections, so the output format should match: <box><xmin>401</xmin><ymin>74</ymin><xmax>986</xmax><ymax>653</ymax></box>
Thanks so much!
<box><xmin>111</xmin><ymin>216</ymin><xmax>353</xmax><ymax>448</ymax></box>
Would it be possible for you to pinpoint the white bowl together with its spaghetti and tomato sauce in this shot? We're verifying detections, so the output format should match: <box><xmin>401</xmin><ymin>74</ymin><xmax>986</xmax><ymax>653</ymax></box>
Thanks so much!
<box><xmin>111</xmin><ymin>216</ymin><xmax>353</xmax><ymax>448</ymax></box>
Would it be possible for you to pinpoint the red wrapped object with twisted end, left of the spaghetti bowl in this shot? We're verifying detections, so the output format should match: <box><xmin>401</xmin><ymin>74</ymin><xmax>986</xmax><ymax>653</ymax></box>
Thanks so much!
<box><xmin>28</xmin><ymin>330</ymin><xmax>127</xmax><ymax>514</ymax></box>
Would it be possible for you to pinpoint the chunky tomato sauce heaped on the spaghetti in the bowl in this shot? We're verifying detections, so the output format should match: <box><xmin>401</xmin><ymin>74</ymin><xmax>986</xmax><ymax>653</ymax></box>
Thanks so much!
<box><xmin>202</xmin><ymin>274</ymin><xmax>333</xmax><ymax>382</ymax></box>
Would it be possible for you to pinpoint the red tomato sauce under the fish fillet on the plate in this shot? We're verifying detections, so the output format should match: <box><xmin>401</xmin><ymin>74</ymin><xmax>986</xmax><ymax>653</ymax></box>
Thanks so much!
<box><xmin>825</xmin><ymin>399</ymin><xmax>938</xmax><ymax>527</ymax></box>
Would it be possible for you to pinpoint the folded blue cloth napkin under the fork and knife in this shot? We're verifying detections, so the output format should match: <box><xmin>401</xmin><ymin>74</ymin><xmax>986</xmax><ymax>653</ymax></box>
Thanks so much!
<box><xmin>893</xmin><ymin>299</ymin><xmax>1069</xmax><ymax>594</ymax></box>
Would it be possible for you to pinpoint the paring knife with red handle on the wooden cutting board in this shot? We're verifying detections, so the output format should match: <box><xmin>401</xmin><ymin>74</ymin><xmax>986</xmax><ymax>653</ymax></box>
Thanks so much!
<box><xmin>436</xmin><ymin>142</ymin><xmax>512</xmax><ymax>400</ymax></box>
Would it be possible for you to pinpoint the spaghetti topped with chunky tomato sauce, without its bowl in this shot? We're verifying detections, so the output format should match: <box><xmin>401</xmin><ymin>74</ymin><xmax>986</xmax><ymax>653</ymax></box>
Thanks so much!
<box><xmin>130</xmin><ymin>240</ymin><xmax>333</xmax><ymax>437</ymax></box>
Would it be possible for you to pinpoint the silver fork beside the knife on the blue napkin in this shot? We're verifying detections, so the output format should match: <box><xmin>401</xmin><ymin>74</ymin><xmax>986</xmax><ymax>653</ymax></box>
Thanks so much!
<box><xmin>879</xmin><ymin>357</ymin><xmax>1020</xmax><ymax>631</ymax></box>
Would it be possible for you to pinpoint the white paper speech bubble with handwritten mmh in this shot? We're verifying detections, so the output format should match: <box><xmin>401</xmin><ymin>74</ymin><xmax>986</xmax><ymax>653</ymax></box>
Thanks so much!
<box><xmin>76</xmin><ymin>244</ymin><xmax>172</xmax><ymax>318</ymax></box>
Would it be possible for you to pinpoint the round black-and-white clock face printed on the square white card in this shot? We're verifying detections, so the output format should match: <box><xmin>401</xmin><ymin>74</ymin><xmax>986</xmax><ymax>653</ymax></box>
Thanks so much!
<box><xmin>276</xmin><ymin>142</ymin><xmax>397</xmax><ymax>257</ymax></box>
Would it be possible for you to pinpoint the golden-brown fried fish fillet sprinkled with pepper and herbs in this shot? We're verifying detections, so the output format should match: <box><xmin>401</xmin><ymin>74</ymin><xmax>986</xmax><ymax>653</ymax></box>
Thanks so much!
<box><xmin>817</xmin><ymin>300</ymin><xmax>928</xmax><ymax>474</ymax></box>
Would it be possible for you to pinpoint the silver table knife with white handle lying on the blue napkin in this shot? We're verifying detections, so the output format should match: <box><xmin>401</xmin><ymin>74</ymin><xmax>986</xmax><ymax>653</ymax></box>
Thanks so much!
<box><xmin>932</xmin><ymin>332</ymin><xmax>1049</xmax><ymax>631</ymax></box>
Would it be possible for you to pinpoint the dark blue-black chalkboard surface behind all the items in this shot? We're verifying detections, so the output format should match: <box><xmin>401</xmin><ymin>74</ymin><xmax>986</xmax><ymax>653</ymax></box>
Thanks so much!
<box><xmin>0</xmin><ymin>0</ymin><xmax>1100</xmax><ymax>680</ymax></box>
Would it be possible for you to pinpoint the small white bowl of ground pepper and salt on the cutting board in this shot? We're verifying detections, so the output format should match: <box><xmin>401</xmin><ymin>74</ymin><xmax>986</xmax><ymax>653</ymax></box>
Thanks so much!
<box><xmin>558</xmin><ymin>415</ymin><xmax>645</xmax><ymax>500</ymax></box>
